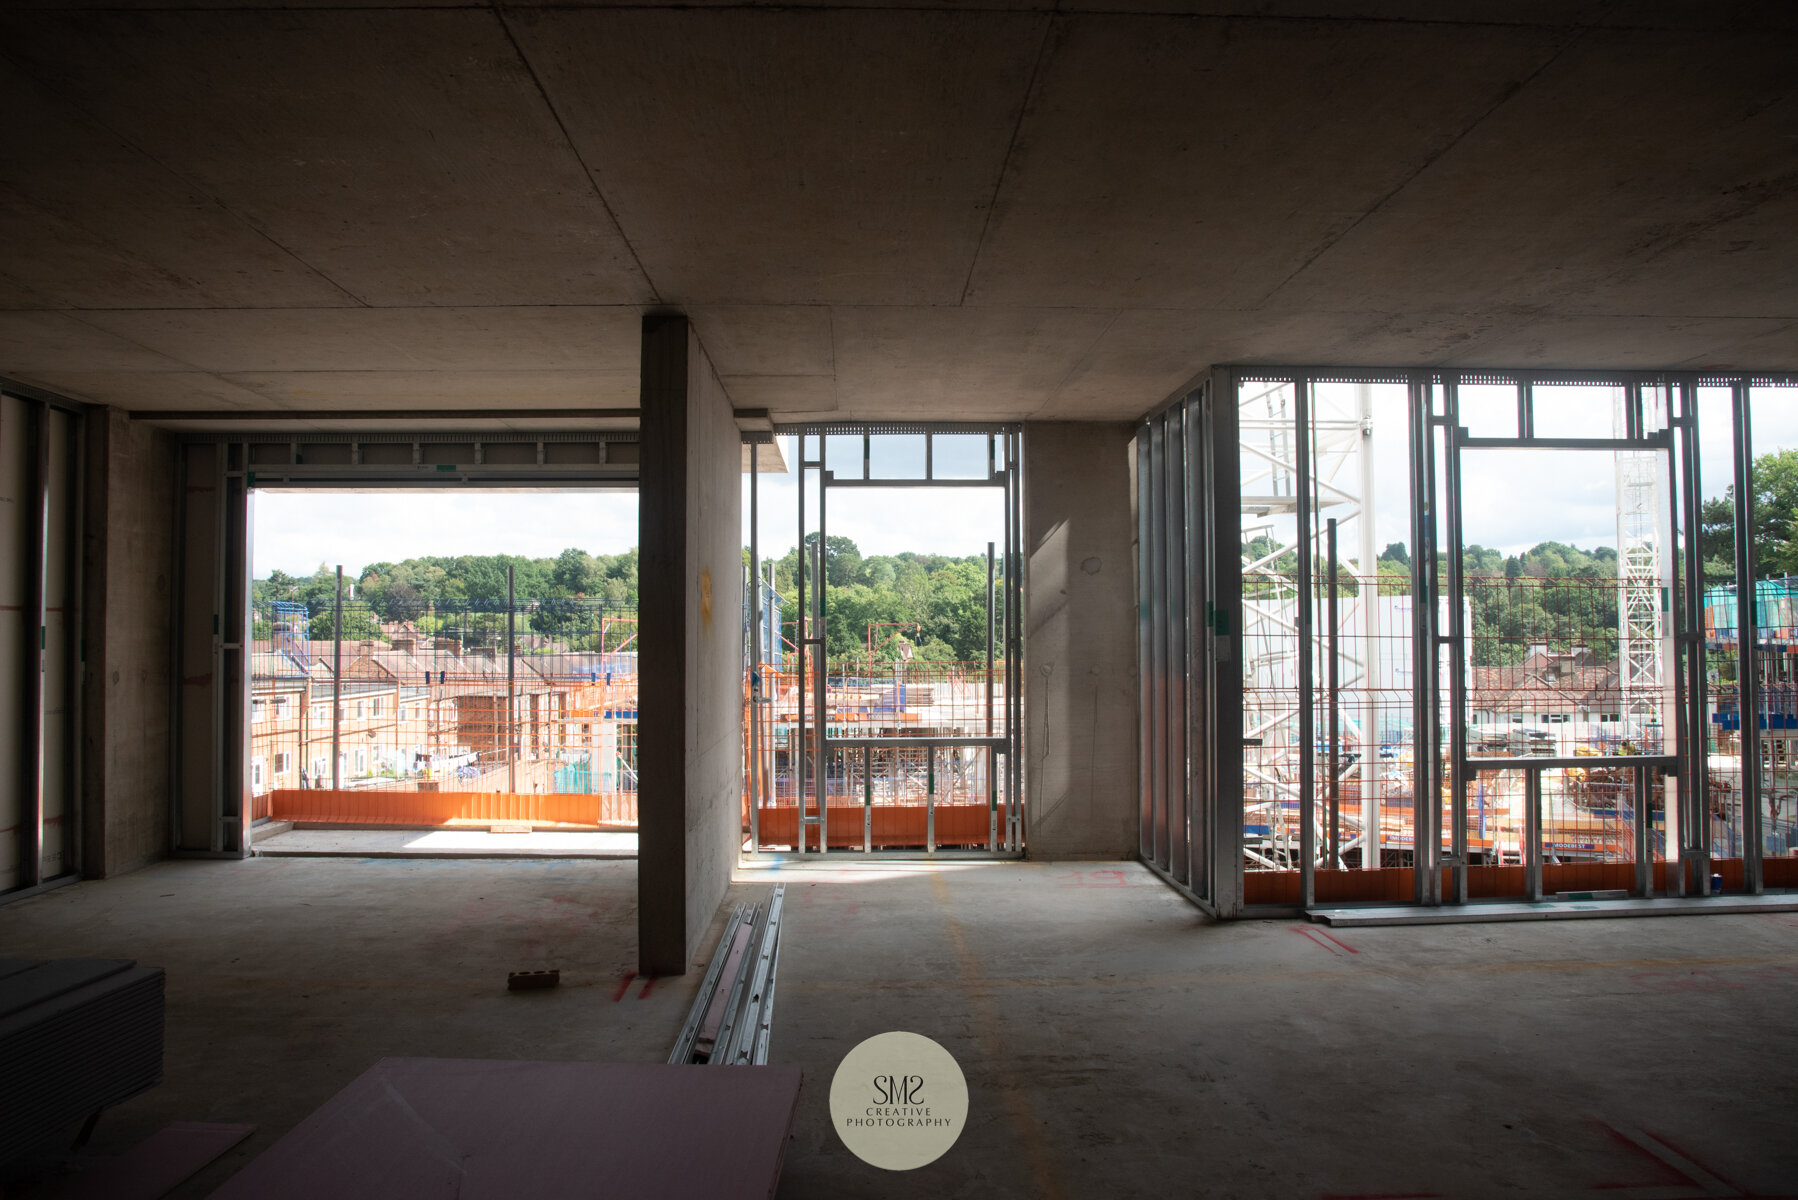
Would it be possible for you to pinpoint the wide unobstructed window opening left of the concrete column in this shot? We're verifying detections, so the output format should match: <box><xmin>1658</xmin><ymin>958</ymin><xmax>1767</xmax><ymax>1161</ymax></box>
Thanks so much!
<box><xmin>248</xmin><ymin>488</ymin><xmax>638</xmax><ymax>845</ymax></box>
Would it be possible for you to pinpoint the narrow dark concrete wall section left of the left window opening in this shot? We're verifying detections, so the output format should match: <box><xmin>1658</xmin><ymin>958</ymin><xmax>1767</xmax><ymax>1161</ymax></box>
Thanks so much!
<box><xmin>81</xmin><ymin>408</ymin><xmax>174</xmax><ymax>878</ymax></box>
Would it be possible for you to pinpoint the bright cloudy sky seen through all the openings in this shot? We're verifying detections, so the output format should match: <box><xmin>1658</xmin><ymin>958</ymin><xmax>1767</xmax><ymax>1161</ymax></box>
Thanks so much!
<box><xmin>254</xmin><ymin>389</ymin><xmax>1798</xmax><ymax>576</ymax></box>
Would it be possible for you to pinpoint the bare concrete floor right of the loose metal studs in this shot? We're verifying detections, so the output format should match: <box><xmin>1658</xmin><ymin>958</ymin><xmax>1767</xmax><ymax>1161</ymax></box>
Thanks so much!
<box><xmin>739</xmin><ymin>864</ymin><xmax>1798</xmax><ymax>1200</ymax></box>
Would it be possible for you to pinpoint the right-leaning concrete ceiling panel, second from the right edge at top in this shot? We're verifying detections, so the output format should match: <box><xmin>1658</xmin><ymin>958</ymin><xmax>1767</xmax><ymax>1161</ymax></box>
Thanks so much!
<box><xmin>969</xmin><ymin>18</ymin><xmax>1566</xmax><ymax>308</ymax></box>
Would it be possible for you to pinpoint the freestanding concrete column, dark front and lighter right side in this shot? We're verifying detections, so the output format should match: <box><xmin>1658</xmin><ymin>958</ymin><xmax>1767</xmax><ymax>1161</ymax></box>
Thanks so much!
<box><xmin>636</xmin><ymin>317</ymin><xmax>743</xmax><ymax>975</ymax></box>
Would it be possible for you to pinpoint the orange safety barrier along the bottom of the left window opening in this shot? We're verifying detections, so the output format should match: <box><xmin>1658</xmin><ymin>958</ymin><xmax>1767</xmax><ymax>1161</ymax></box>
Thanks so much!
<box><xmin>268</xmin><ymin>788</ymin><xmax>636</xmax><ymax>831</ymax></box>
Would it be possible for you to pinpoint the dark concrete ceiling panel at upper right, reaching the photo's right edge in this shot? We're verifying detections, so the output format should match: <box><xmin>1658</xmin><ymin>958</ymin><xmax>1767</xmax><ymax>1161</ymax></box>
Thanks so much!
<box><xmin>1271</xmin><ymin>31</ymin><xmax>1798</xmax><ymax>317</ymax></box>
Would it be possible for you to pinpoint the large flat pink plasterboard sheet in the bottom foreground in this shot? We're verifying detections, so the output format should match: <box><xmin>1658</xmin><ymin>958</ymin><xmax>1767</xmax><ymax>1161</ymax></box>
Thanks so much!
<box><xmin>212</xmin><ymin>1058</ymin><xmax>800</xmax><ymax>1200</ymax></box>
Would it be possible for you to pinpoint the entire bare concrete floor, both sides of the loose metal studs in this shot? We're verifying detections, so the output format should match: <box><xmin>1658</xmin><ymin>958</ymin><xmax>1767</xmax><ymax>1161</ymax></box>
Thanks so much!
<box><xmin>0</xmin><ymin>858</ymin><xmax>1798</xmax><ymax>1200</ymax></box>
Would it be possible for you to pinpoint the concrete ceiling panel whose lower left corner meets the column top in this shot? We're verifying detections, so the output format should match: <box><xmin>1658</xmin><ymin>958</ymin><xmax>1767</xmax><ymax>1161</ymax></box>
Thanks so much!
<box><xmin>509</xmin><ymin>9</ymin><xmax>1046</xmax><ymax>306</ymax></box>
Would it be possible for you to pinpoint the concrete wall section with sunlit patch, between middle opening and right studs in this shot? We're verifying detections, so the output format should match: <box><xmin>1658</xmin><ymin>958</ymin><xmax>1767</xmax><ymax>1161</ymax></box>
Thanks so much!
<box><xmin>1023</xmin><ymin>421</ymin><xmax>1136</xmax><ymax>858</ymax></box>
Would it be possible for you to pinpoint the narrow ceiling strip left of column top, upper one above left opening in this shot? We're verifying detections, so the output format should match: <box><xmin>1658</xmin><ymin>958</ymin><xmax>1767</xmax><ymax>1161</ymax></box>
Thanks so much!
<box><xmin>83</xmin><ymin>306</ymin><xmax>642</xmax><ymax>378</ymax></box>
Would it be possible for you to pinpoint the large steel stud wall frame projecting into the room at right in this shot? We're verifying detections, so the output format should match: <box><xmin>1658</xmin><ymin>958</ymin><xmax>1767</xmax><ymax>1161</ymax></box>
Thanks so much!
<box><xmin>1135</xmin><ymin>367</ymin><xmax>1798</xmax><ymax>918</ymax></box>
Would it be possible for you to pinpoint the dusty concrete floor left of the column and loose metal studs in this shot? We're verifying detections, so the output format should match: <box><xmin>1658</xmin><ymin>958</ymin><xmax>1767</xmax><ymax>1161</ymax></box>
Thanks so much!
<box><xmin>0</xmin><ymin>858</ymin><xmax>683</xmax><ymax>1200</ymax></box>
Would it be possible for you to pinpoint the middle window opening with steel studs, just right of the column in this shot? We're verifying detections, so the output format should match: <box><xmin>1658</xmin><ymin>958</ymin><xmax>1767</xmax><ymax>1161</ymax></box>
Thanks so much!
<box><xmin>744</xmin><ymin>425</ymin><xmax>1023</xmax><ymax>855</ymax></box>
